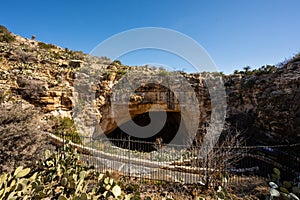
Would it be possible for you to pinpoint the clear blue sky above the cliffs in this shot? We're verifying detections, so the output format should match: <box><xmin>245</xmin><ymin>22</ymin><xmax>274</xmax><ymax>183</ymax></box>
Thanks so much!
<box><xmin>0</xmin><ymin>0</ymin><xmax>300</xmax><ymax>73</ymax></box>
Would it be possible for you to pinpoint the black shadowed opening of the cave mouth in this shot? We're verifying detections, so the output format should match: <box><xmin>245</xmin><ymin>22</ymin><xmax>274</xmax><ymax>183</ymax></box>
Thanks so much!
<box><xmin>107</xmin><ymin>111</ymin><xmax>186</xmax><ymax>152</ymax></box>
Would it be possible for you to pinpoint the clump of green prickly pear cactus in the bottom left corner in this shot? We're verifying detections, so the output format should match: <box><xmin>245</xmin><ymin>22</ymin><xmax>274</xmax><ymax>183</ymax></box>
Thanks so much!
<box><xmin>0</xmin><ymin>141</ymin><xmax>129</xmax><ymax>200</ymax></box>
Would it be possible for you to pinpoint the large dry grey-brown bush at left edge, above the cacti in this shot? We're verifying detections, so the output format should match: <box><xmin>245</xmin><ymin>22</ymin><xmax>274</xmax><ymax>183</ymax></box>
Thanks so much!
<box><xmin>0</xmin><ymin>104</ymin><xmax>53</xmax><ymax>172</ymax></box>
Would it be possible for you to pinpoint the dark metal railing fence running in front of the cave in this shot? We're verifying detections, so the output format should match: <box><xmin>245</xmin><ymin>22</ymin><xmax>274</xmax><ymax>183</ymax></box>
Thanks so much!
<box><xmin>51</xmin><ymin>134</ymin><xmax>300</xmax><ymax>183</ymax></box>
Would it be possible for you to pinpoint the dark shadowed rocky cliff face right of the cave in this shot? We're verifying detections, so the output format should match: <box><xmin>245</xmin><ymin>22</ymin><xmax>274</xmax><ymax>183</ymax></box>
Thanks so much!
<box><xmin>225</xmin><ymin>59</ymin><xmax>300</xmax><ymax>143</ymax></box>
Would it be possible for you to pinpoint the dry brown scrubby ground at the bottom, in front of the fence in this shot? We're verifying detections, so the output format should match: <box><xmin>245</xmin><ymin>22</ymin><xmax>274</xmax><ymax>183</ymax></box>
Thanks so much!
<box><xmin>116</xmin><ymin>177</ymin><xmax>269</xmax><ymax>200</ymax></box>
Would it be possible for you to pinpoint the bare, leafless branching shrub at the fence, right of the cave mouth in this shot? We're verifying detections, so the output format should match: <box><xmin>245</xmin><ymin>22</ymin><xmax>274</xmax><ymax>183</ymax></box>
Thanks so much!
<box><xmin>189</xmin><ymin>123</ymin><xmax>245</xmax><ymax>190</ymax></box>
